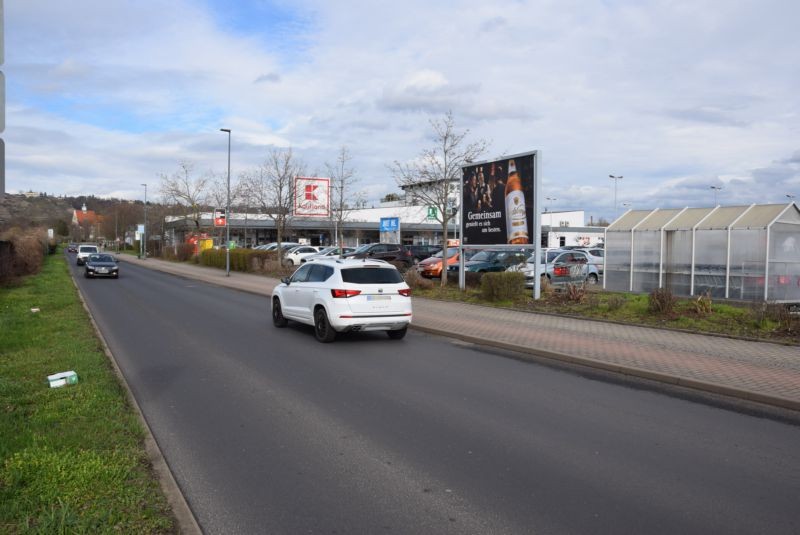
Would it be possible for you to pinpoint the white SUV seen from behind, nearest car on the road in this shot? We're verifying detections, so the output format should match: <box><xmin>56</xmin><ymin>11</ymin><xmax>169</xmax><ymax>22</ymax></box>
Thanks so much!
<box><xmin>272</xmin><ymin>259</ymin><xmax>411</xmax><ymax>342</ymax></box>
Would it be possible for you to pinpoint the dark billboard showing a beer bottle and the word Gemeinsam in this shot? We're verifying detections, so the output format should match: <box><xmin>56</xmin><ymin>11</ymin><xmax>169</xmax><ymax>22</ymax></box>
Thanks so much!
<box><xmin>461</xmin><ymin>151</ymin><xmax>538</xmax><ymax>245</ymax></box>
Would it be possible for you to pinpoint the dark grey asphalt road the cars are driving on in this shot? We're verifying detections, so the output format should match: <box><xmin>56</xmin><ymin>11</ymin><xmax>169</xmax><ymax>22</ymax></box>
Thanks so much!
<box><xmin>69</xmin><ymin>256</ymin><xmax>800</xmax><ymax>534</ymax></box>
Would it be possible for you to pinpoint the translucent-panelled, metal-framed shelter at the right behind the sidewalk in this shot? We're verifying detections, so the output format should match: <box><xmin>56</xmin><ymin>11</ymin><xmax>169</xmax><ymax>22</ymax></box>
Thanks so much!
<box><xmin>603</xmin><ymin>203</ymin><xmax>800</xmax><ymax>303</ymax></box>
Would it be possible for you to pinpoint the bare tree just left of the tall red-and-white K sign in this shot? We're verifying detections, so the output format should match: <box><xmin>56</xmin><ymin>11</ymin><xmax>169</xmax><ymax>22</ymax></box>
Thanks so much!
<box><xmin>245</xmin><ymin>147</ymin><xmax>305</xmax><ymax>263</ymax></box>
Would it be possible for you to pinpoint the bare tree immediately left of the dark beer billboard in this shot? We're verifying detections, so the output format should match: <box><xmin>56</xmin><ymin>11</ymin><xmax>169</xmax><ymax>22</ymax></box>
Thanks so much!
<box><xmin>392</xmin><ymin>112</ymin><xmax>489</xmax><ymax>286</ymax></box>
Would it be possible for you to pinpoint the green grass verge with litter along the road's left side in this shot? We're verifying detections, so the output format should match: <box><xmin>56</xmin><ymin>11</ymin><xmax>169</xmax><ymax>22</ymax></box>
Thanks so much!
<box><xmin>0</xmin><ymin>255</ymin><xmax>176</xmax><ymax>533</ymax></box>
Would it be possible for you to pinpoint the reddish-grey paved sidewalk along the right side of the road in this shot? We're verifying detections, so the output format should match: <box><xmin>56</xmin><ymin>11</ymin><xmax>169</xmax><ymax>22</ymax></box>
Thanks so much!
<box><xmin>120</xmin><ymin>255</ymin><xmax>800</xmax><ymax>410</ymax></box>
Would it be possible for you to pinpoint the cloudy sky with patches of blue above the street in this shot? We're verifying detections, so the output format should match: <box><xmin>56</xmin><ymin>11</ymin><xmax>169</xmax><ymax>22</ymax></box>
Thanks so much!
<box><xmin>3</xmin><ymin>0</ymin><xmax>800</xmax><ymax>220</ymax></box>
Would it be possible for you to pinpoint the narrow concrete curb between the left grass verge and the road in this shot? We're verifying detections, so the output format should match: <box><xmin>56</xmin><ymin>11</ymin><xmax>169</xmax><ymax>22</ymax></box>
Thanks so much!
<box><xmin>67</xmin><ymin>267</ymin><xmax>203</xmax><ymax>535</ymax></box>
